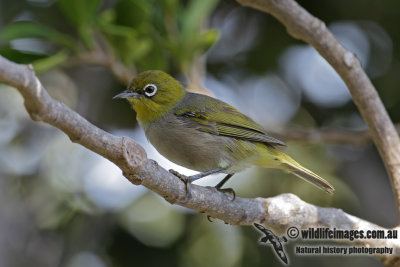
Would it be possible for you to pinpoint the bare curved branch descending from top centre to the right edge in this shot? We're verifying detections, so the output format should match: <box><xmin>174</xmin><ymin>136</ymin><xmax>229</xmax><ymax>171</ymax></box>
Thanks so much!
<box><xmin>237</xmin><ymin>0</ymin><xmax>400</xmax><ymax>221</ymax></box>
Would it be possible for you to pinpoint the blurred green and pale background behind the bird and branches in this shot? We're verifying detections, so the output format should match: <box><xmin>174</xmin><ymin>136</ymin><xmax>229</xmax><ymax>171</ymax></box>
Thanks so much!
<box><xmin>0</xmin><ymin>0</ymin><xmax>400</xmax><ymax>267</ymax></box>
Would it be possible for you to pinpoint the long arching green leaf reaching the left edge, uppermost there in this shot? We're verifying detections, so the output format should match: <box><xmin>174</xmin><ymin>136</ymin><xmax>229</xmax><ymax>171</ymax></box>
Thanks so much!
<box><xmin>0</xmin><ymin>21</ymin><xmax>77</xmax><ymax>51</ymax></box>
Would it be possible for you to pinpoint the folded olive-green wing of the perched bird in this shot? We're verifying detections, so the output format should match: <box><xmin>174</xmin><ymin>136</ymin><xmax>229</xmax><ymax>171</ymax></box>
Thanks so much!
<box><xmin>174</xmin><ymin>93</ymin><xmax>286</xmax><ymax>146</ymax></box>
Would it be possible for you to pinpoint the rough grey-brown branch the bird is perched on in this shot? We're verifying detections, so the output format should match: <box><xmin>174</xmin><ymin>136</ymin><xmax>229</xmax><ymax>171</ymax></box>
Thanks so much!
<box><xmin>0</xmin><ymin>52</ymin><xmax>400</xmax><ymax>262</ymax></box>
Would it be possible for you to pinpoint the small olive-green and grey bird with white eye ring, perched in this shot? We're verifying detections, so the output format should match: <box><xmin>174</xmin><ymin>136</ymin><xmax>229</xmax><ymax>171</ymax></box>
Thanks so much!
<box><xmin>114</xmin><ymin>70</ymin><xmax>334</xmax><ymax>197</ymax></box>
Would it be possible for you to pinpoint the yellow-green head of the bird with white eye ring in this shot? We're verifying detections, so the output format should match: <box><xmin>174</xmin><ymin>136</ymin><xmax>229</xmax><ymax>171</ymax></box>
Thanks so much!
<box><xmin>114</xmin><ymin>70</ymin><xmax>186</xmax><ymax>124</ymax></box>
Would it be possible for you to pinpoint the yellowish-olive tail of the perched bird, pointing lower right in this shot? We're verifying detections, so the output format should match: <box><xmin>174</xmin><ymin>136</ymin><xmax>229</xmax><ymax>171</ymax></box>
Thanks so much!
<box><xmin>257</xmin><ymin>148</ymin><xmax>335</xmax><ymax>194</ymax></box>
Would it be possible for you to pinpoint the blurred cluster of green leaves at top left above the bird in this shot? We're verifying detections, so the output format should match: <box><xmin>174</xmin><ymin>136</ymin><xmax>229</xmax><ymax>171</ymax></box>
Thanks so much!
<box><xmin>0</xmin><ymin>0</ymin><xmax>218</xmax><ymax>75</ymax></box>
